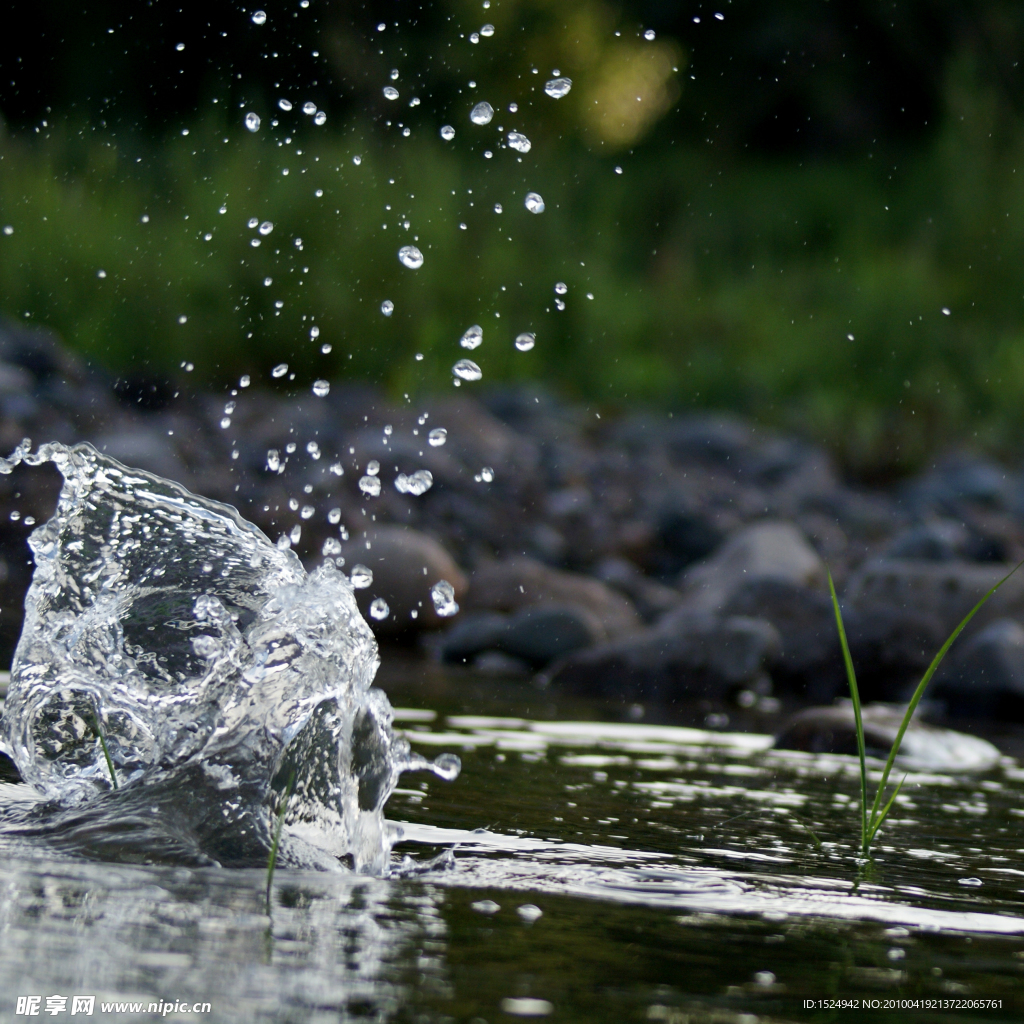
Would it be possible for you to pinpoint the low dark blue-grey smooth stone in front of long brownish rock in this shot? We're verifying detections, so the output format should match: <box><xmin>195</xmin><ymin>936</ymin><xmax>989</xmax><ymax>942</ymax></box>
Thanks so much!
<box><xmin>440</xmin><ymin>604</ymin><xmax>605</xmax><ymax>669</ymax></box>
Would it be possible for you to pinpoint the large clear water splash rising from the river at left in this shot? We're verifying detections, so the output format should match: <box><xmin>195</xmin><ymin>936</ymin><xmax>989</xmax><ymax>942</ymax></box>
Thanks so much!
<box><xmin>0</xmin><ymin>441</ymin><xmax>458</xmax><ymax>872</ymax></box>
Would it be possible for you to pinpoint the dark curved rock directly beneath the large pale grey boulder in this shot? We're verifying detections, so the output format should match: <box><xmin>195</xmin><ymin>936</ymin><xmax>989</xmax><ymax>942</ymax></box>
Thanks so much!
<box><xmin>723</xmin><ymin>580</ymin><xmax>846</xmax><ymax>701</ymax></box>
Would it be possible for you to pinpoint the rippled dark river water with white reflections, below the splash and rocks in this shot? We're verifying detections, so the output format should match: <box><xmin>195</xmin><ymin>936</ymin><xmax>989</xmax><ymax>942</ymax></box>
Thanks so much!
<box><xmin>0</xmin><ymin>653</ymin><xmax>1024</xmax><ymax>1024</ymax></box>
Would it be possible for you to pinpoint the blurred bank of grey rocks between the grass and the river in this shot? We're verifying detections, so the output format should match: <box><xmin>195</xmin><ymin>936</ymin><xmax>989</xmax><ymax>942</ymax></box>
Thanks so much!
<box><xmin>0</xmin><ymin>317</ymin><xmax>1024</xmax><ymax>721</ymax></box>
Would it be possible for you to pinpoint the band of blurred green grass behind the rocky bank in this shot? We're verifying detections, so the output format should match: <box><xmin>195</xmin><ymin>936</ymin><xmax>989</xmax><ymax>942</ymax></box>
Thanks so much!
<box><xmin>0</xmin><ymin>74</ymin><xmax>1024</xmax><ymax>478</ymax></box>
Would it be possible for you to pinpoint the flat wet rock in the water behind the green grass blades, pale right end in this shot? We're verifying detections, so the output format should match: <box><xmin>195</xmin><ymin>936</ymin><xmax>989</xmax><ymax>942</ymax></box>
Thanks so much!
<box><xmin>775</xmin><ymin>700</ymin><xmax>999</xmax><ymax>781</ymax></box>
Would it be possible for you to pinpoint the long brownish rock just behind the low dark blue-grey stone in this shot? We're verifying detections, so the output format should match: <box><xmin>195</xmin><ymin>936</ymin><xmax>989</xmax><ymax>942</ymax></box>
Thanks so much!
<box><xmin>466</xmin><ymin>557</ymin><xmax>642</xmax><ymax>638</ymax></box>
